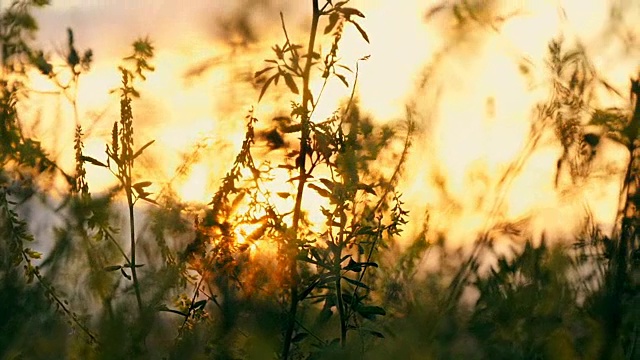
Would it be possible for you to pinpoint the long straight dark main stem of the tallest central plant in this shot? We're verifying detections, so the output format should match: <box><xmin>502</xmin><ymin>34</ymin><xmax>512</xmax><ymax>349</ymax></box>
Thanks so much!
<box><xmin>282</xmin><ymin>0</ymin><xmax>320</xmax><ymax>360</ymax></box>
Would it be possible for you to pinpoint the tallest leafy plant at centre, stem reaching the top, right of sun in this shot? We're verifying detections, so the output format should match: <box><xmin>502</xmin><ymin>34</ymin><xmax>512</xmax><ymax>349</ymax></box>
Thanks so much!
<box><xmin>256</xmin><ymin>0</ymin><xmax>406</xmax><ymax>359</ymax></box>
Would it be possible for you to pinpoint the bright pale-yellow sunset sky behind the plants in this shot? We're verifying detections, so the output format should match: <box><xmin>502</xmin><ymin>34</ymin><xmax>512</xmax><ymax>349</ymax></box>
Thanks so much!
<box><xmin>17</xmin><ymin>0</ymin><xmax>640</xmax><ymax>250</ymax></box>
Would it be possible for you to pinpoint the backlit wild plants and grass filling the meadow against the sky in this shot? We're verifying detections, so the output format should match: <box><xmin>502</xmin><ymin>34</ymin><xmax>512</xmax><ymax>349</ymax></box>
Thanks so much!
<box><xmin>0</xmin><ymin>0</ymin><xmax>640</xmax><ymax>359</ymax></box>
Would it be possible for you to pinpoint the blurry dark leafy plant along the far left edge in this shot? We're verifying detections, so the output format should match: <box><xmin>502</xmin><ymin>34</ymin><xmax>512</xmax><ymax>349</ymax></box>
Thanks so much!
<box><xmin>0</xmin><ymin>1</ymin><xmax>102</xmax><ymax>350</ymax></box>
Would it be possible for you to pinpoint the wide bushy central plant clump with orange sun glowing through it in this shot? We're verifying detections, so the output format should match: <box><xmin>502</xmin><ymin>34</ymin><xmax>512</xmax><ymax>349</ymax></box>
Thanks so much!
<box><xmin>165</xmin><ymin>1</ymin><xmax>412</xmax><ymax>358</ymax></box>
